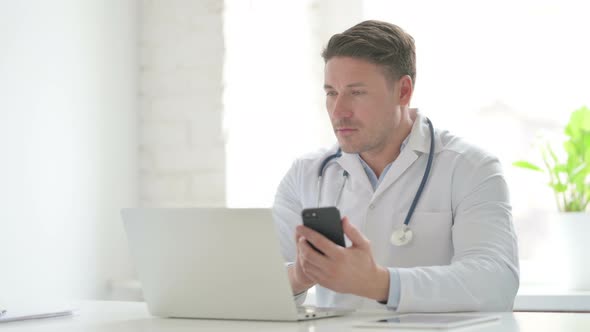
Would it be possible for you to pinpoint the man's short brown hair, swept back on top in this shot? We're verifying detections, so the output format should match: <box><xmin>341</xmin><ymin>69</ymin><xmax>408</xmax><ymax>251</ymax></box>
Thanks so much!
<box><xmin>322</xmin><ymin>20</ymin><xmax>416</xmax><ymax>83</ymax></box>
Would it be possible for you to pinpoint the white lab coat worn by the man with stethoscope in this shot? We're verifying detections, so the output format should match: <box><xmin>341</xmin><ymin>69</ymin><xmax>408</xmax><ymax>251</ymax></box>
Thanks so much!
<box><xmin>273</xmin><ymin>112</ymin><xmax>519</xmax><ymax>312</ymax></box>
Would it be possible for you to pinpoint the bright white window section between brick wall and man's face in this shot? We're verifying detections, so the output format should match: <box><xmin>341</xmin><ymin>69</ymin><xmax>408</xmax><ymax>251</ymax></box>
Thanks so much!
<box><xmin>224</xmin><ymin>0</ymin><xmax>363</xmax><ymax>207</ymax></box>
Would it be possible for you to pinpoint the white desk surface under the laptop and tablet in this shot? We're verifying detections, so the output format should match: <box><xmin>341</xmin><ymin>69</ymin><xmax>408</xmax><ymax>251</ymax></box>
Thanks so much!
<box><xmin>0</xmin><ymin>301</ymin><xmax>590</xmax><ymax>332</ymax></box>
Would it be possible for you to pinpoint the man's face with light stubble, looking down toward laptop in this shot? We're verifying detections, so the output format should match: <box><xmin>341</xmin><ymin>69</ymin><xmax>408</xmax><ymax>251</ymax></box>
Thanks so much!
<box><xmin>324</xmin><ymin>57</ymin><xmax>410</xmax><ymax>153</ymax></box>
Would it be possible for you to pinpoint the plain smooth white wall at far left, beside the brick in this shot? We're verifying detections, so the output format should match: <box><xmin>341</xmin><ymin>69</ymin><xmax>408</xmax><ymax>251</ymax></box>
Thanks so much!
<box><xmin>0</xmin><ymin>0</ymin><xmax>137</xmax><ymax>305</ymax></box>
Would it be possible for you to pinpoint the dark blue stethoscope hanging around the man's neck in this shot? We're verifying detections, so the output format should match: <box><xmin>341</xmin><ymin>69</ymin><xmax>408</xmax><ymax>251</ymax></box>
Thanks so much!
<box><xmin>317</xmin><ymin>118</ymin><xmax>434</xmax><ymax>247</ymax></box>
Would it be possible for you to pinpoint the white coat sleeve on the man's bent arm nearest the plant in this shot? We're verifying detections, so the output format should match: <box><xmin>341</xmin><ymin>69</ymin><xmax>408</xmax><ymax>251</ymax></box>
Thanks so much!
<box><xmin>397</xmin><ymin>154</ymin><xmax>519</xmax><ymax>312</ymax></box>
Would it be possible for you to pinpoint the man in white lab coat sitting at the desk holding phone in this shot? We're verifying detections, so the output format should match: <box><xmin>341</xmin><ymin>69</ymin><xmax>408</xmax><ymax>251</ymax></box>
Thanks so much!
<box><xmin>273</xmin><ymin>21</ymin><xmax>519</xmax><ymax>312</ymax></box>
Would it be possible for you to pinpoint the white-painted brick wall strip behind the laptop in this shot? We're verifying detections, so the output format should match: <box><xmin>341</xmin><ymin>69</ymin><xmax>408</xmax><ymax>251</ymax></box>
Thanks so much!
<box><xmin>139</xmin><ymin>0</ymin><xmax>225</xmax><ymax>206</ymax></box>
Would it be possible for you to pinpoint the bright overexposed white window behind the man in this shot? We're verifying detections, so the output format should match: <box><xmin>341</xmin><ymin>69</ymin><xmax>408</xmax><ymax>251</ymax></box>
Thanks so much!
<box><xmin>225</xmin><ymin>0</ymin><xmax>590</xmax><ymax>283</ymax></box>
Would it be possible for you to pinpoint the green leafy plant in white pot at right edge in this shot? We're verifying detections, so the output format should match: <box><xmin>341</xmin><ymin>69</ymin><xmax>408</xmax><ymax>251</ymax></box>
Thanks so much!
<box><xmin>513</xmin><ymin>107</ymin><xmax>590</xmax><ymax>290</ymax></box>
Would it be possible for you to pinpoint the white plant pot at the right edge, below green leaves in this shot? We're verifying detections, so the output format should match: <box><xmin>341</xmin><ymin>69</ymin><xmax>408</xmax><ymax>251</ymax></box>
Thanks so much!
<box><xmin>549</xmin><ymin>212</ymin><xmax>590</xmax><ymax>290</ymax></box>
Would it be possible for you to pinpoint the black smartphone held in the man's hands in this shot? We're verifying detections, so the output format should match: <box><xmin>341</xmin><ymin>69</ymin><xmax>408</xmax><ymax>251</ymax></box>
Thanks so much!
<box><xmin>301</xmin><ymin>206</ymin><xmax>346</xmax><ymax>253</ymax></box>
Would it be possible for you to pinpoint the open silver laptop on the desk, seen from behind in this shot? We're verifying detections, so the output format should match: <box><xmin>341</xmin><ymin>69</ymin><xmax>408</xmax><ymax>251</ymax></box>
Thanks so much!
<box><xmin>121</xmin><ymin>208</ymin><xmax>351</xmax><ymax>321</ymax></box>
